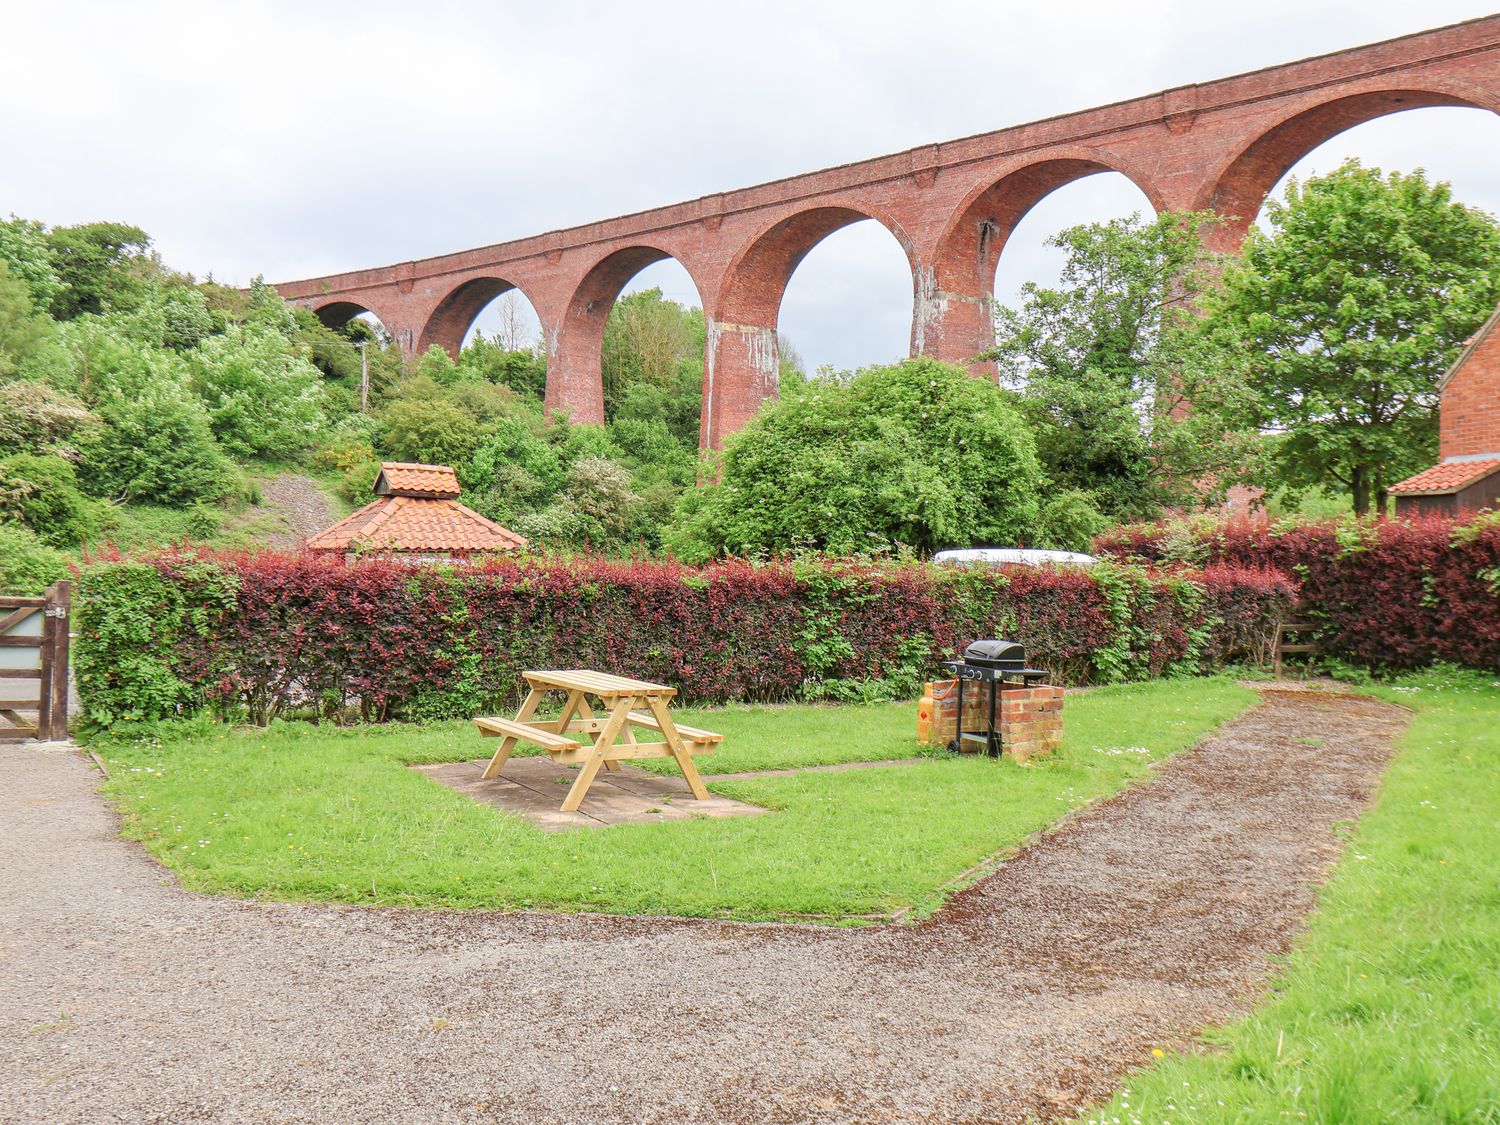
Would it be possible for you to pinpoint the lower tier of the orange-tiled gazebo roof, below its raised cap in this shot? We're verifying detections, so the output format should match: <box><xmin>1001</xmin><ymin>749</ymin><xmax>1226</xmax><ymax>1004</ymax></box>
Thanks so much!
<box><xmin>308</xmin><ymin>497</ymin><xmax>527</xmax><ymax>554</ymax></box>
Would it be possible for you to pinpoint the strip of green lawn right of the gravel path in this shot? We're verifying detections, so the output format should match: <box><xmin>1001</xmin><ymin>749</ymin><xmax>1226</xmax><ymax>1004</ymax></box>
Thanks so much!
<box><xmin>1085</xmin><ymin>674</ymin><xmax>1500</xmax><ymax>1125</ymax></box>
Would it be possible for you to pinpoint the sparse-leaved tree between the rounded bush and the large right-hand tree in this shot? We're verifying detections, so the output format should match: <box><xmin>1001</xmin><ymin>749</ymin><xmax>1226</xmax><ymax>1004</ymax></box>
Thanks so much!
<box><xmin>989</xmin><ymin>213</ymin><xmax>1242</xmax><ymax>518</ymax></box>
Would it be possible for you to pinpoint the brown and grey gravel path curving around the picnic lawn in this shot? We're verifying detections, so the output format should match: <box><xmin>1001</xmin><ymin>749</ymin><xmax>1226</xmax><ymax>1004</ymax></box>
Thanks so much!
<box><xmin>0</xmin><ymin>693</ymin><xmax>1406</xmax><ymax>1122</ymax></box>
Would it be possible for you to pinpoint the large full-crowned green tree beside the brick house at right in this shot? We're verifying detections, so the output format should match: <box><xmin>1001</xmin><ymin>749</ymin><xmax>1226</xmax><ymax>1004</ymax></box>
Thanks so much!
<box><xmin>1190</xmin><ymin>161</ymin><xmax>1500</xmax><ymax>515</ymax></box>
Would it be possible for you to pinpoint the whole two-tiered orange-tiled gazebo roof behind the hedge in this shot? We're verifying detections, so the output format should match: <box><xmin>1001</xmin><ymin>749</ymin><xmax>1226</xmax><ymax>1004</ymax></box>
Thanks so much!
<box><xmin>308</xmin><ymin>461</ymin><xmax>527</xmax><ymax>555</ymax></box>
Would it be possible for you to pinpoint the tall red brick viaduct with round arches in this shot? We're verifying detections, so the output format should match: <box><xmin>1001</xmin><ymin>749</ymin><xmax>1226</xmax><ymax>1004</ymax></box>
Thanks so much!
<box><xmin>276</xmin><ymin>15</ymin><xmax>1500</xmax><ymax>447</ymax></box>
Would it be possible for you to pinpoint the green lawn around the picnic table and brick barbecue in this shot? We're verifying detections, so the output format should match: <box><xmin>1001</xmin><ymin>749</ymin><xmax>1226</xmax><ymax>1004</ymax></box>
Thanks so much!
<box><xmin>101</xmin><ymin>680</ymin><xmax>1256</xmax><ymax>918</ymax></box>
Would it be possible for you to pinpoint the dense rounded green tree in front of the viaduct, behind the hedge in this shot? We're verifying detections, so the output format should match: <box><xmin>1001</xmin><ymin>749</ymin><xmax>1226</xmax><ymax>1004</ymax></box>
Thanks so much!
<box><xmin>666</xmin><ymin>359</ymin><xmax>1041</xmax><ymax>560</ymax></box>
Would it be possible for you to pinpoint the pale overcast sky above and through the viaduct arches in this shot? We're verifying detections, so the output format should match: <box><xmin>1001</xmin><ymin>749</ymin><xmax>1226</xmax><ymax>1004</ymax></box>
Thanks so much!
<box><xmin>0</xmin><ymin>0</ymin><xmax>1500</xmax><ymax>368</ymax></box>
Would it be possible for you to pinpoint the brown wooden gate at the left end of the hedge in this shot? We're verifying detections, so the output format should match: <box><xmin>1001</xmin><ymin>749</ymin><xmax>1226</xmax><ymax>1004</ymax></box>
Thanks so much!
<box><xmin>0</xmin><ymin>582</ymin><xmax>72</xmax><ymax>740</ymax></box>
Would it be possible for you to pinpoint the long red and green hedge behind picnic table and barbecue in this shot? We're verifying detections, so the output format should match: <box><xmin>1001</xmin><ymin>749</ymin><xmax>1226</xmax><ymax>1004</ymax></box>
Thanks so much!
<box><xmin>78</xmin><ymin>551</ymin><xmax>1292</xmax><ymax>725</ymax></box>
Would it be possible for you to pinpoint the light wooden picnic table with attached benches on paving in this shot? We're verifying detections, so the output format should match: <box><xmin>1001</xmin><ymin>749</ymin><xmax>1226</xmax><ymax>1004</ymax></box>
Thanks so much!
<box><xmin>474</xmin><ymin>668</ymin><xmax>723</xmax><ymax>813</ymax></box>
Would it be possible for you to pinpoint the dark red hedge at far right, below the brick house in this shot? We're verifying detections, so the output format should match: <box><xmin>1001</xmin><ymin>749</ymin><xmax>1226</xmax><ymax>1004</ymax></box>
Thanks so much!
<box><xmin>1095</xmin><ymin>513</ymin><xmax>1500</xmax><ymax>669</ymax></box>
